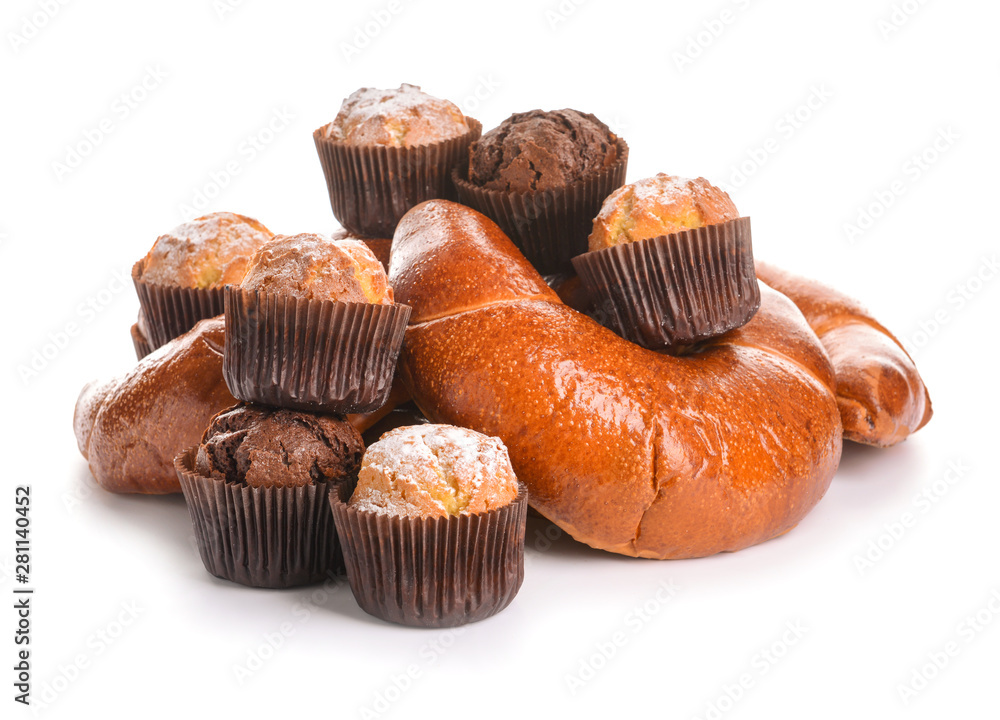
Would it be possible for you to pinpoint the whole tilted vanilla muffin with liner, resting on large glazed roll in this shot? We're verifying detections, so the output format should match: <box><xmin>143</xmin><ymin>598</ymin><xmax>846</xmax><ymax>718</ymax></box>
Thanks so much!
<box><xmin>573</xmin><ymin>173</ymin><xmax>760</xmax><ymax>354</ymax></box>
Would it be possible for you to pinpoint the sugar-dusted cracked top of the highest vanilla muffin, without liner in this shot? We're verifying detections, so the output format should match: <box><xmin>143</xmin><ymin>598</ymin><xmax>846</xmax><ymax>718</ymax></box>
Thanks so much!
<box><xmin>322</xmin><ymin>83</ymin><xmax>469</xmax><ymax>148</ymax></box>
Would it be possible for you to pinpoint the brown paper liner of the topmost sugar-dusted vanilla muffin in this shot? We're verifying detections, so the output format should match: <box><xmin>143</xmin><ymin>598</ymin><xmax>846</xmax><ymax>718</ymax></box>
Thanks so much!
<box><xmin>313</xmin><ymin>118</ymin><xmax>483</xmax><ymax>238</ymax></box>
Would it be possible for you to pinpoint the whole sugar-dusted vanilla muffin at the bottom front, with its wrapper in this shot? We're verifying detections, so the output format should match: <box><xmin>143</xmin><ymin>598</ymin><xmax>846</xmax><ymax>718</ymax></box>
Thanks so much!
<box><xmin>330</xmin><ymin>425</ymin><xmax>528</xmax><ymax>627</ymax></box>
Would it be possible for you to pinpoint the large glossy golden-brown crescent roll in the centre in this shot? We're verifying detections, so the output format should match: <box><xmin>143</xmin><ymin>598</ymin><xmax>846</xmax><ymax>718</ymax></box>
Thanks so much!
<box><xmin>390</xmin><ymin>201</ymin><xmax>841</xmax><ymax>558</ymax></box>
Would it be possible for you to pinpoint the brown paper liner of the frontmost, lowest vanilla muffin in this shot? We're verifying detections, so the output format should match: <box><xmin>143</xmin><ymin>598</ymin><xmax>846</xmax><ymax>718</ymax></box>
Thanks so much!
<box><xmin>330</xmin><ymin>481</ymin><xmax>528</xmax><ymax>627</ymax></box>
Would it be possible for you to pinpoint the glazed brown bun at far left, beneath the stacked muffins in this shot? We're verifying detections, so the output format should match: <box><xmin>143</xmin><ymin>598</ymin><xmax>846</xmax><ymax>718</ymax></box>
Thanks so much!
<box><xmin>73</xmin><ymin>317</ymin><xmax>236</xmax><ymax>495</ymax></box>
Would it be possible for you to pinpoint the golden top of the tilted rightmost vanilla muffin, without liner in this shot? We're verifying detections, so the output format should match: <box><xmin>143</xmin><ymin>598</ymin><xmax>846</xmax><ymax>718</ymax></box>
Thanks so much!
<box><xmin>589</xmin><ymin>173</ymin><xmax>740</xmax><ymax>252</ymax></box>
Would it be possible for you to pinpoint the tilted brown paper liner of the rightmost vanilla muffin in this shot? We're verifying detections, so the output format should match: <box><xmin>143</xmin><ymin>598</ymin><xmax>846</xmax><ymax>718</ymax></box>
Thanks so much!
<box><xmin>573</xmin><ymin>217</ymin><xmax>760</xmax><ymax>348</ymax></box>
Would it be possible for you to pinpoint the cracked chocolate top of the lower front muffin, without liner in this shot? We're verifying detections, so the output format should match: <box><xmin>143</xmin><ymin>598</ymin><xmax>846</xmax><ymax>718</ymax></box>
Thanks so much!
<box><xmin>195</xmin><ymin>405</ymin><xmax>364</xmax><ymax>487</ymax></box>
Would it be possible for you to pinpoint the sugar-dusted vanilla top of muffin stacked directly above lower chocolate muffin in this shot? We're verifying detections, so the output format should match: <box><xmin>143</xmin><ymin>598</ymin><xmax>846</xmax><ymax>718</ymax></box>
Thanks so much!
<box><xmin>241</xmin><ymin>233</ymin><xmax>393</xmax><ymax>305</ymax></box>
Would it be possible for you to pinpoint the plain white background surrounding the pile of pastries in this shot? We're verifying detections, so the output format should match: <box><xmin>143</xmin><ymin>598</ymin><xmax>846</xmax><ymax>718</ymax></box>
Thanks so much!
<box><xmin>0</xmin><ymin>0</ymin><xmax>1000</xmax><ymax>718</ymax></box>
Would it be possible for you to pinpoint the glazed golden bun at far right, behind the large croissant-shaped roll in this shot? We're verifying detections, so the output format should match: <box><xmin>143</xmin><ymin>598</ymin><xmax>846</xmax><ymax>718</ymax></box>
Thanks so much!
<box><xmin>757</xmin><ymin>262</ymin><xmax>933</xmax><ymax>447</ymax></box>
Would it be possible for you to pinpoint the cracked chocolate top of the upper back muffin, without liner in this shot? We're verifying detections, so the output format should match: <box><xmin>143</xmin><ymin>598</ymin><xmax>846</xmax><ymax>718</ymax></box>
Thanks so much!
<box><xmin>469</xmin><ymin>110</ymin><xmax>618</xmax><ymax>192</ymax></box>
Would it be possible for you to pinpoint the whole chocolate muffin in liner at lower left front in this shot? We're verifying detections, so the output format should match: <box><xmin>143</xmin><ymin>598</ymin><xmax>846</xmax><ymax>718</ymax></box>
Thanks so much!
<box><xmin>174</xmin><ymin>405</ymin><xmax>364</xmax><ymax>588</ymax></box>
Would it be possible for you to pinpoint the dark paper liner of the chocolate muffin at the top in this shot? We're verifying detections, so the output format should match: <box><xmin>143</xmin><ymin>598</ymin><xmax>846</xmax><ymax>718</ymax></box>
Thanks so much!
<box><xmin>452</xmin><ymin>138</ymin><xmax>628</xmax><ymax>274</ymax></box>
